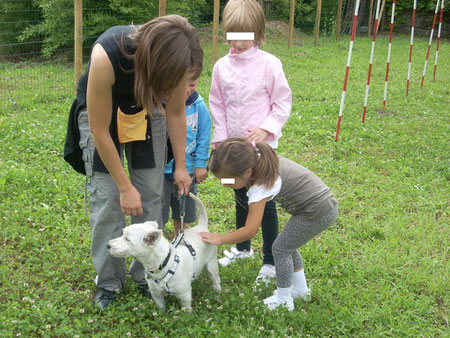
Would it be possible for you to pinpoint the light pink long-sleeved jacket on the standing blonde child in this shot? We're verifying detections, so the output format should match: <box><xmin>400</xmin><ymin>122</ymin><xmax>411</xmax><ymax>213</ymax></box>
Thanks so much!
<box><xmin>209</xmin><ymin>46</ymin><xmax>292</xmax><ymax>148</ymax></box>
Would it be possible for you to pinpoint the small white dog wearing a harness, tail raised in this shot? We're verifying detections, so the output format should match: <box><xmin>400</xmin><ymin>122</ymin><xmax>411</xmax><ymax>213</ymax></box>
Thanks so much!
<box><xmin>107</xmin><ymin>194</ymin><xmax>221</xmax><ymax>311</ymax></box>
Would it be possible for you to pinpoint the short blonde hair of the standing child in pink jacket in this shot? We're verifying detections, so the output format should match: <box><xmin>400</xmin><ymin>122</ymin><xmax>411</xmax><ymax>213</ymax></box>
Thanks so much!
<box><xmin>222</xmin><ymin>0</ymin><xmax>266</xmax><ymax>46</ymax></box>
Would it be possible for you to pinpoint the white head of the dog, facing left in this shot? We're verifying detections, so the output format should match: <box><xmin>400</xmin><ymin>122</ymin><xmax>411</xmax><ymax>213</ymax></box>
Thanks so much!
<box><xmin>107</xmin><ymin>222</ymin><xmax>162</xmax><ymax>260</ymax></box>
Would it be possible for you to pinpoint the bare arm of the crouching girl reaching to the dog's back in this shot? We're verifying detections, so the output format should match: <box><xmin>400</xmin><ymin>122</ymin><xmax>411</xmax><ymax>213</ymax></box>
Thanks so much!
<box><xmin>199</xmin><ymin>197</ymin><xmax>269</xmax><ymax>245</ymax></box>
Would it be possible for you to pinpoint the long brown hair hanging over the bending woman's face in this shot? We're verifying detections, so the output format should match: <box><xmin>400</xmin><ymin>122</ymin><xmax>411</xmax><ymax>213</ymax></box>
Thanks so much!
<box><xmin>127</xmin><ymin>15</ymin><xmax>203</xmax><ymax>112</ymax></box>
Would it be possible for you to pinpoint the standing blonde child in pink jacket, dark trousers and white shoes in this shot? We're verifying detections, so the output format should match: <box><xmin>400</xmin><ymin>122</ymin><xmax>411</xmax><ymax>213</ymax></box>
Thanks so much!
<box><xmin>209</xmin><ymin>0</ymin><xmax>292</xmax><ymax>282</ymax></box>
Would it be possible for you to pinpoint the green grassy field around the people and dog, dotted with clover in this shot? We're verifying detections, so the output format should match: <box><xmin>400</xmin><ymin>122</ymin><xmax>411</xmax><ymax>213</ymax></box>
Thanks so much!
<box><xmin>0</xmin><ymin>29</ymin><xmax>450</xmax><ymax>337</ymax></box>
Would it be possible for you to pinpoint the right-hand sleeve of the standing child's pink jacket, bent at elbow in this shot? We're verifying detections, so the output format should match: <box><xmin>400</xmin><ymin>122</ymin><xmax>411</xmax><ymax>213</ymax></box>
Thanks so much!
<box><xmin>259</xmin><ymin>59</ymin><xmax>292</xmax><ymax>139</ymax></box>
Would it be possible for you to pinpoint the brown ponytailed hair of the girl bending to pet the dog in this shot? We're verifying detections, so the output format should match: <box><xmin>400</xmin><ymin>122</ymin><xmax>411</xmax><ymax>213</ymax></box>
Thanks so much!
<box><xmin>209</xmin><ymin>137</ymin><xmax>280</xmax><ymax>189</ymax></box>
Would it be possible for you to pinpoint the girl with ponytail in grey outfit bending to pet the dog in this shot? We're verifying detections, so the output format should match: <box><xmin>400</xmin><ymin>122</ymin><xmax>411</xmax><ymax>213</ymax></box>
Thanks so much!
<box><xmin>200</xmin><ymin>137</ymin><xmax>338</xmax><ymax>311</ymax></box>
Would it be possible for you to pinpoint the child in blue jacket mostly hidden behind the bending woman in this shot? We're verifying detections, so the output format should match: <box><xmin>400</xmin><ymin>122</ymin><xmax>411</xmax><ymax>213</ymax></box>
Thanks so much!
<box><xmin>162</xmin><ymin>79</ymin><xmax>211</xmax><ymax>239</ymax></box>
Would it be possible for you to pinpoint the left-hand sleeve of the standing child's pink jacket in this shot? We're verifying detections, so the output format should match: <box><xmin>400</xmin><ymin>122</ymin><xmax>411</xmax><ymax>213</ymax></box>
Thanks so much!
<box><xmin>209</xmin><ymin>63</ymin><xmax>228</xmax><ymax>143</ymax></box>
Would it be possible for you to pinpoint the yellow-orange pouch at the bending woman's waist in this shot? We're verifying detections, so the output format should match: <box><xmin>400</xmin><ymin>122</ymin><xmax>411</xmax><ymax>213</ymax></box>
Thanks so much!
<box><xmin>117</xmin><ymin>106</ymin><xmax>148</xmax><ymax>143</ymax></box>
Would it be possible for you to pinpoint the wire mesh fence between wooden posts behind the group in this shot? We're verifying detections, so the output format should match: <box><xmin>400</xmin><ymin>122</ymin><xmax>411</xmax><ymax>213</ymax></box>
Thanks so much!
<box><xmin>0</xmin><ymin>0</ymin><xmax>382</xmax><ymax>109</ymax></box>
